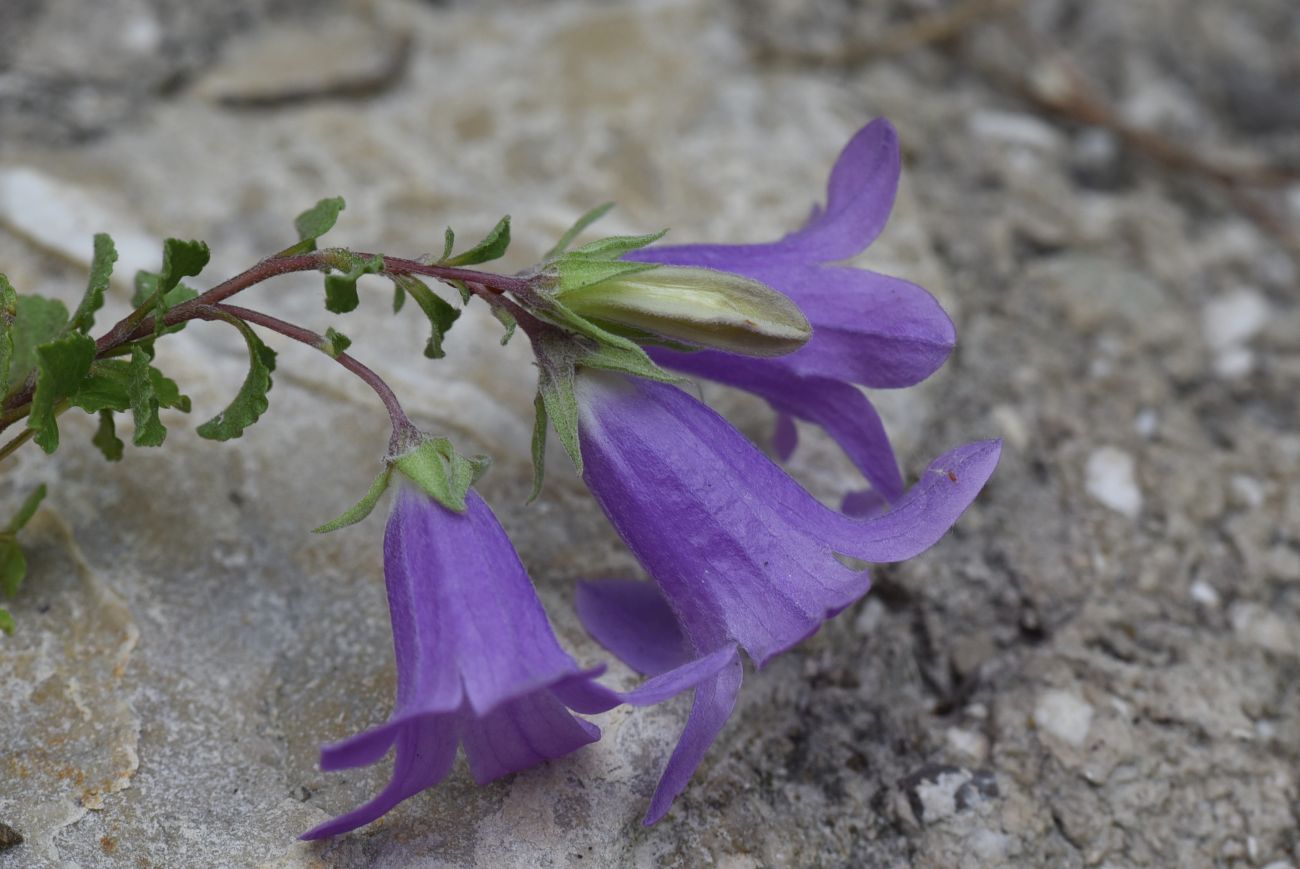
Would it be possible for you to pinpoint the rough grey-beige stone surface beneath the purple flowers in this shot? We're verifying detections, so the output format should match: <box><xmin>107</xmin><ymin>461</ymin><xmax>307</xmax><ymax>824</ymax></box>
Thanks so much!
<box><xmin>0</xmin><ymin>0</ymin><xmax>1300</xmax><ymax>869</ymax></box>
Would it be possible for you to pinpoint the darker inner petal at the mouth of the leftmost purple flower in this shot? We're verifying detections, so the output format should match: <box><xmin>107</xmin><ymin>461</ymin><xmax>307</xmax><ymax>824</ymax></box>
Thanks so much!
<box><xmin>462</xmin><ymin>691</ymin><xmax>601</xmax><ymax>784</ymax></box>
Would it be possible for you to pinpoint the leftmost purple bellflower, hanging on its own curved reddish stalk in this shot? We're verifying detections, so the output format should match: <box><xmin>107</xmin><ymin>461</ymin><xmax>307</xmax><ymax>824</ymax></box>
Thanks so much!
<box><xmin>303</xmin><ymin>485</ymin><xmax>611</xmax><ymax>839</ymax></box>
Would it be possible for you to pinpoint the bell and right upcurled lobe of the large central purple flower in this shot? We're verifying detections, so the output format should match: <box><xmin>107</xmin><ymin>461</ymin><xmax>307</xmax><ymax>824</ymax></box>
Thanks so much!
<box><xmin>577</xmin><ymin>372</ymin><xmax>998</xmax><ymax>666</ymax></box>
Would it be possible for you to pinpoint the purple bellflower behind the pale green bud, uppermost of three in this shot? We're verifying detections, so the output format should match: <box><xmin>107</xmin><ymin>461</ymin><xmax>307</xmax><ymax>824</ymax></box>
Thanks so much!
<box><xmin>628</xmin><ymin>118</ymin><xmax>956</xmax><ymax>501</ymax></box>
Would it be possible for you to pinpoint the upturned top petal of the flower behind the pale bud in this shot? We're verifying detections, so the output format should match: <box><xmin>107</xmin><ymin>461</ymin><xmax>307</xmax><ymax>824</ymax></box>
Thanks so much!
<box><xmin>629</xmin><ymin>118</ymin><xmax>900</xmax><ymax>267</ymax></box>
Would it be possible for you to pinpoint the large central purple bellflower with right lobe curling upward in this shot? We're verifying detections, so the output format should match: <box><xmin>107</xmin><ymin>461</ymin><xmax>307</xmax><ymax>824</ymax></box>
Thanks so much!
<box><xmin>566</xmin><ymin>372</ymin><xmax>1001</xmax><ymax>823</ymax></box>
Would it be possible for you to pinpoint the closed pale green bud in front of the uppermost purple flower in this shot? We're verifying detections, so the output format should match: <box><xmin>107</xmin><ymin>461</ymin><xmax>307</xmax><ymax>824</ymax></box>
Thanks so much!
<box><xmin>555</xmin><ymin>265</ymin><xmax>813</xmax><ymax>356</ymax></box>
